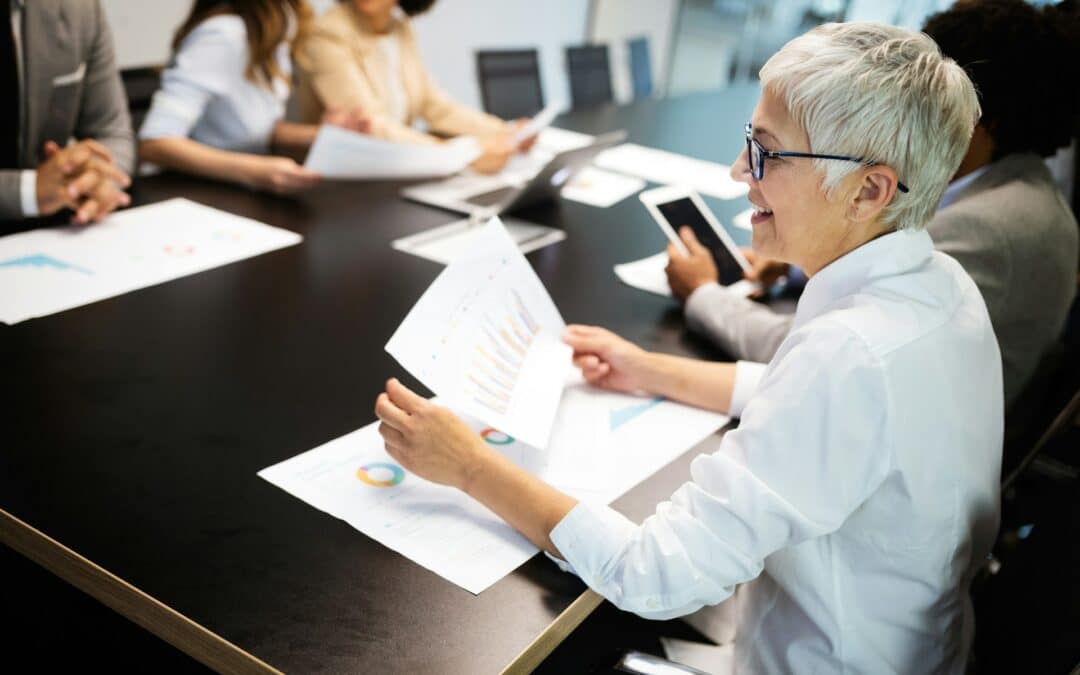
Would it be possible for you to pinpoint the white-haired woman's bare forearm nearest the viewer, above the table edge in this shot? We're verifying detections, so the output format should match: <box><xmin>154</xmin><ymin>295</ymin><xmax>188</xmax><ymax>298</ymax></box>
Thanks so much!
<box><xmin>461</xmin><ymin>451</ymin><xmax>578</xmax><ymax>557</ymax></box>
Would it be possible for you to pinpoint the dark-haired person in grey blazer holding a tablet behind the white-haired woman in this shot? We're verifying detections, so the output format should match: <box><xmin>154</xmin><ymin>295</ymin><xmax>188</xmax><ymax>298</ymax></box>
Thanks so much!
<box><xmin>667</xmin><ymin>0</ymin><xmax>1080</xmax><ymax>407</ymax></box>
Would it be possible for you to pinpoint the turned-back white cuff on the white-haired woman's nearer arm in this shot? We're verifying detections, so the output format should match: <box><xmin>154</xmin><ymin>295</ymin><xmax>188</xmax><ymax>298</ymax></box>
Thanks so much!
<box><xmin>549</xmin><ymin>502</ymin><xmax>637</xmax><ymax>587</ymax></box>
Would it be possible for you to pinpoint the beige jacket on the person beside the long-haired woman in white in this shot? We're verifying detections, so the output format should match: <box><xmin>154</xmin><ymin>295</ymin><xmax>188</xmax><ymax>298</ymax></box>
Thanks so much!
<box><xmin>295</xmin><ymin>2</ymin><xmax>502</xmax><ymax>143</ymax></box>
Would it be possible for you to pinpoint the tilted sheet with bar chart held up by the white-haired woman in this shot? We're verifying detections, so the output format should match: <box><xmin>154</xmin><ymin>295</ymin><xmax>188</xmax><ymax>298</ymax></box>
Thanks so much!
<box><xmin>386</xmin><ymin>218</ymin><xmax>571</xmax><ymax>448</ymax></box>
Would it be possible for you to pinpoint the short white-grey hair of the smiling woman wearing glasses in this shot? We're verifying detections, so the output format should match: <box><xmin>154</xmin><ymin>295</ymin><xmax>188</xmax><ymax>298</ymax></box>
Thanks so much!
<box><xmin>760</xmin><ymin>23</ymin><xmax>980</xmax><ymax>229</ymax></box>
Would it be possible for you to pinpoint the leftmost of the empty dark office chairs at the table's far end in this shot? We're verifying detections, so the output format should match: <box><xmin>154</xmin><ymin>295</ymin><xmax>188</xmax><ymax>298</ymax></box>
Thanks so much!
<box><xmin>476</xmin><ymin>49</ymin><xmax>543</xmax><ymax>120</ymax></box>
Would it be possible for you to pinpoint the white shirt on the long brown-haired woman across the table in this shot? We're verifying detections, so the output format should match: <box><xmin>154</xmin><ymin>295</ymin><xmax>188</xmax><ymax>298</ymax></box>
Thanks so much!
<box><xmin>138</xmin><ymin>14</ymin><xmax>293</xmax><ymax>153</ymax></box>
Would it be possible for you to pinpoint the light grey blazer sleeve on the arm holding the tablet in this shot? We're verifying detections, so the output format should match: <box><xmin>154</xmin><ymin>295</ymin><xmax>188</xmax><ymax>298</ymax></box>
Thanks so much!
<box><xmin>685</xmin><ymin>284</ymin><xmax>795</xmax><ymax>363</ymax></box>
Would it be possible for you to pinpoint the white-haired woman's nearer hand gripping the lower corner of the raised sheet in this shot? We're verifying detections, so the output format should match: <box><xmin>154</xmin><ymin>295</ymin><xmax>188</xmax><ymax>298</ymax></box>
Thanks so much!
<box><xmin>375</xmin><ymin>378</ymin><xmax>491</xmax><ymax>490</ymax></box>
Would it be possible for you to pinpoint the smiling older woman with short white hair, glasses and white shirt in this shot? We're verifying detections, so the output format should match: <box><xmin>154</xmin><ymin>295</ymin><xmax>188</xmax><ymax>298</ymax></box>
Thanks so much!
<box><xmin>376</xmin><ymin>24</ymin><xmax>1002</xmax><ymax>673</ymax></box>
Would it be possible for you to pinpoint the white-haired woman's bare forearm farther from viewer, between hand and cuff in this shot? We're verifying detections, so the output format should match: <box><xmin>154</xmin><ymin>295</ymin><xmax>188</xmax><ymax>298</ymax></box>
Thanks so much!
<box><xmin>640</xmin><ymin>352</ymin><xmax>735</xmax><ymax>414</ymax></box>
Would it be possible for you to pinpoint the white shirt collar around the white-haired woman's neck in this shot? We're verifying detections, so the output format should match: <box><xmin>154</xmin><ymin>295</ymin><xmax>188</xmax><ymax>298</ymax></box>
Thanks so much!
<box><xmin>793</xmin><ymin>229</ymin><xmax>934</xmax><ymax>328</ymax></box>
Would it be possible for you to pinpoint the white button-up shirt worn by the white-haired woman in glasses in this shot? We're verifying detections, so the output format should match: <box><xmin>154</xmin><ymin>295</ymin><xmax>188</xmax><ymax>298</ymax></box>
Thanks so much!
<box><xmin>551</xmin><ymin>231</ymin><xmax>1003</xmax><ymax>673</ymax></box>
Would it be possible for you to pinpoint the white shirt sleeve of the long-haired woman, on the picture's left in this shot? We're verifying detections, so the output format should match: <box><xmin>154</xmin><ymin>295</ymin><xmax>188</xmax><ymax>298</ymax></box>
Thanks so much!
<box><xmin>138</xmin><ymin>16</ymin><xmax>247</xmax><ymax>140</ymax></box>
